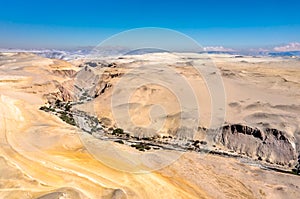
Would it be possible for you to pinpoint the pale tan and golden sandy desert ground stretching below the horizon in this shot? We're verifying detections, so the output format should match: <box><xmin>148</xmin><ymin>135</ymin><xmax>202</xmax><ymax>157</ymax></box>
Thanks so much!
<box><xmin>0</xmin><ymin>52</ymin><xmax>300</xmax><ymax>199</ymax></box>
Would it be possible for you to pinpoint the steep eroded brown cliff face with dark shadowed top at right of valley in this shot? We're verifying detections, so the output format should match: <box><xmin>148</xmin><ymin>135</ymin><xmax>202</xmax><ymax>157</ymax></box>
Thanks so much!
<box><xmin>216</xmin><ymin>124</ymin><xmax>297</xmax><ymax>167</ymax></box>
